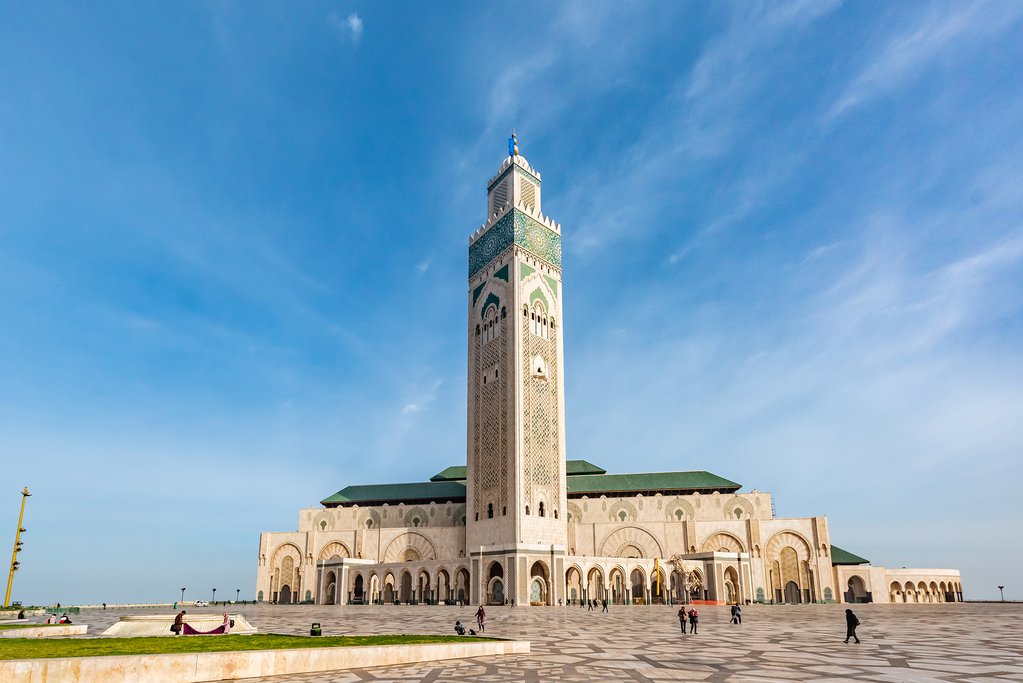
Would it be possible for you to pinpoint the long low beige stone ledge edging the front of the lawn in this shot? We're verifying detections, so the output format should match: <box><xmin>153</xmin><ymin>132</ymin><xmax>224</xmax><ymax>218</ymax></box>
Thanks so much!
<box><xmin>0</xmin><ymin>639</ymin><xmax>530</xmax><ymax>683</ymax></box>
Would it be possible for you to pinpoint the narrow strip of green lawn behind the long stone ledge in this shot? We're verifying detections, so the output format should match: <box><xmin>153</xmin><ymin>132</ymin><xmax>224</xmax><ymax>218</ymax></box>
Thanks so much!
<box><xmin>0</xmin><ymin>633</ymin><xmax>493</xmax><ymax>659</ymax></box>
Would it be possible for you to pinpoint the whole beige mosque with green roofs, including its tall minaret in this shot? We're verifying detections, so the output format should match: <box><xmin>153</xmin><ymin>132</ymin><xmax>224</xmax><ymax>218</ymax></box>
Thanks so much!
<box><xmin>256</xmin><ymin>138</ymin><xmax>963</xmax><ymax>606</ymax></box>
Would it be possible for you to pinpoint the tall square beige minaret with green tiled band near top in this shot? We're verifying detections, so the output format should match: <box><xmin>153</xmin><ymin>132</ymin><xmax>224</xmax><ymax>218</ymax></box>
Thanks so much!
<box><xmin>465</xmin><ymin>134</ymin><xmax>568</xmax><ymax>605</ymax></box>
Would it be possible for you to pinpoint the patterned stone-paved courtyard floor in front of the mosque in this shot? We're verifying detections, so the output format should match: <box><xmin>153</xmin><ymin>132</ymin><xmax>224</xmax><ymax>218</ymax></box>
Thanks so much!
<box><xmin>65</xmin><ymin>603</ymin><xmax>1023</xmax><ymax>683</ymax></box>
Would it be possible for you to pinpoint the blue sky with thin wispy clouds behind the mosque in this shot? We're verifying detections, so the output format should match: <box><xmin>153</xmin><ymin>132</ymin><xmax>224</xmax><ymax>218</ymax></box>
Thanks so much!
<box><xmin>0</xmin><ymin>0</ymin><xmax>1023</xmax><ymax>603</ymax></box>
